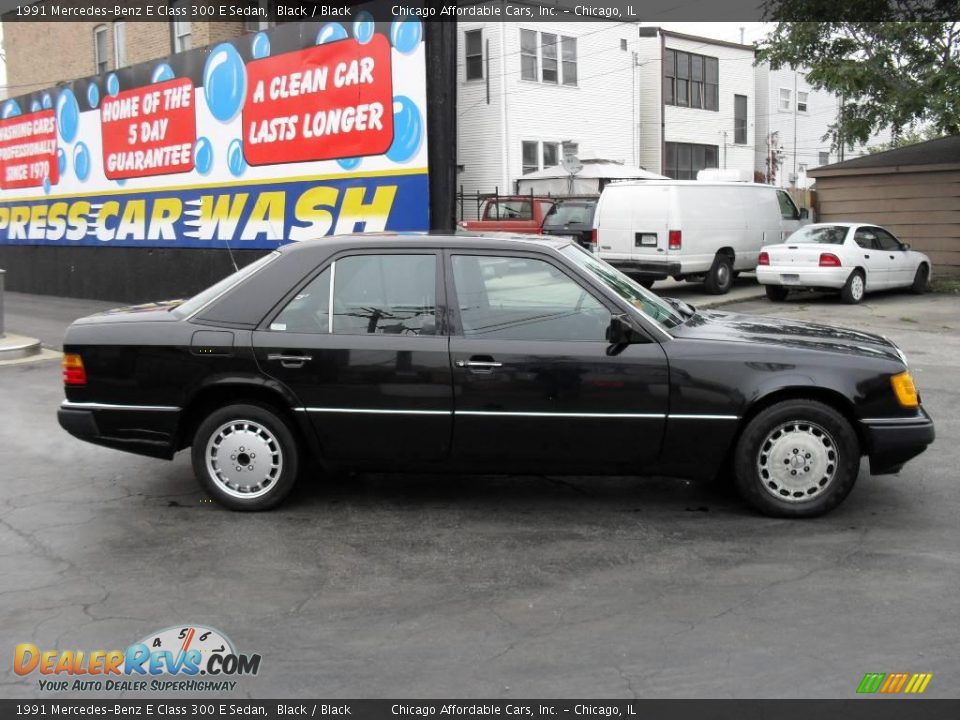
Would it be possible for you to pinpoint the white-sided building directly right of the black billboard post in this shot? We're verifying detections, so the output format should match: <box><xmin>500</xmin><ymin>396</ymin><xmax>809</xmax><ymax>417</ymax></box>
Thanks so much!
<box><xmin>457</xmin><ymin>21</ymin><xmax>640</xmax><ymax>202</ymax></box>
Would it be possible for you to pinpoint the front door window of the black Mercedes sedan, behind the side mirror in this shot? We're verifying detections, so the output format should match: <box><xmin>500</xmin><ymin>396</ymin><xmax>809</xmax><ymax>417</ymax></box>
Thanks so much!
<box><xmin>453</xmin><ymin>255</ymin><xmax>610</xmax><ymax>342</ymax></box>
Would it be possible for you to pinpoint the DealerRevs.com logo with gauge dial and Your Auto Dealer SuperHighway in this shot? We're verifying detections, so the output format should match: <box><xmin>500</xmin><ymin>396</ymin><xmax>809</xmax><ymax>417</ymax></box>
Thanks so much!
<box><xmin>13</xmin><ymin>625</ymin><xmax>260</xmax><ymax>692</ymax></box>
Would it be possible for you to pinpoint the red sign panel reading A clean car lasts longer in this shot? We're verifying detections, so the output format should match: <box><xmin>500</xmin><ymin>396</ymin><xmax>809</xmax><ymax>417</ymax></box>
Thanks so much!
<box><xmin>243</xmin><ymin>34</ymin><xmax>393</xmax><ymax>165</ymax></box>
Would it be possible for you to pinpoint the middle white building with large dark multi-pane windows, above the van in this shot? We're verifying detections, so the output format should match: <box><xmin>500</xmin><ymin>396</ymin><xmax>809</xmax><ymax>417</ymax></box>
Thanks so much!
<box><xmin>638</xmin><ymin>27</ymin><xmax>756</xmax><ymax>180</ymax></box>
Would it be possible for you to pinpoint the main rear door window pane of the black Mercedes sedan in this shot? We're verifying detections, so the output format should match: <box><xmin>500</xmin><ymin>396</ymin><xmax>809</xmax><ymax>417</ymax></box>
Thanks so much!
<box><xmin>333</xmin><ymin>255</ymin><xmax>437</xmax><ymax>335</ymax></box>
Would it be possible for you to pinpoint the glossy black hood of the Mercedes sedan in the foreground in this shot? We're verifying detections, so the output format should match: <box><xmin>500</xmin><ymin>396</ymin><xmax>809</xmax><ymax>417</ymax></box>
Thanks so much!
<box><xmin>670</xmin><ymin>311</ymin><xmax>902</xmax><ymax>362</ymax></box>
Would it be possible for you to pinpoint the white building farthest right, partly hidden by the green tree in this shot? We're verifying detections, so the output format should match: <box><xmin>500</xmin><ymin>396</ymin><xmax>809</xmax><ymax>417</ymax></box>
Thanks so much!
<box><xmin>755</xmin><ymin>64</ymin><xmax>890</xmax><ymax>188</ymax></box>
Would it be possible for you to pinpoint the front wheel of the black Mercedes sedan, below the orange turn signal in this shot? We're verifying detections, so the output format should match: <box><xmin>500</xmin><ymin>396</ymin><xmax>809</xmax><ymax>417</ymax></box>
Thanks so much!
<box><xmin>734</xmin><ymin>400</ymin><xmax>860</xmax><ymax>518</ymax></box>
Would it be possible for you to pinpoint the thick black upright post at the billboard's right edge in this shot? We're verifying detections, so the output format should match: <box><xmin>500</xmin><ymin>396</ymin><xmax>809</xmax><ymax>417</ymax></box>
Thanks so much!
<box><xmin>423</xmin><ymin>22</ymin><xmax>457</xmax><ymax>232</ymax></box>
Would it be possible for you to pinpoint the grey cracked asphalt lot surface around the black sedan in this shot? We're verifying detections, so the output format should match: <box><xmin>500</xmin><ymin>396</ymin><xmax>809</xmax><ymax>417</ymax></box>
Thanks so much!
<box><xmin>0</xmin><ymin>286</ymin><xmax>960</xmax><ymax>698</ymax></box>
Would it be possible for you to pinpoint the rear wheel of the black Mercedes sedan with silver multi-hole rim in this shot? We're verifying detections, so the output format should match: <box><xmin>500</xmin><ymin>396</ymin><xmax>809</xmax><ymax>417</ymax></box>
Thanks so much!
<box><xmin>191</xmin><ymin>403</ymin><xmax>299</xmax><ymax>512</ymax></box>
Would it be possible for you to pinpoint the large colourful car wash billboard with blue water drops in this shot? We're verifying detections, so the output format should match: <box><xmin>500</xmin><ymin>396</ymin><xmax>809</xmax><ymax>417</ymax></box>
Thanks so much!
<box><xmin>0</xmin><ymin>14</ymin><xmax>429</xmax><ymax>249</ymax></box>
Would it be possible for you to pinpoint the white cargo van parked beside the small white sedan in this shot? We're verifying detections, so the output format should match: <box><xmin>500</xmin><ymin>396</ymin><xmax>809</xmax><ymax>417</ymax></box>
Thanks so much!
<box><xmin>593</xmin><ymin>180</ymin><xmax>807</xmax><ymax>295</ymax></box>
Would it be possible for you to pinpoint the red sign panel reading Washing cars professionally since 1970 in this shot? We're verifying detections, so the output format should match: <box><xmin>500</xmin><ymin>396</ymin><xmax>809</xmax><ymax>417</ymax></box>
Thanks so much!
<box><xmin>0</xmin><ymin>110</ymin><xmax>60</xmax><ymax>189</ymax></box>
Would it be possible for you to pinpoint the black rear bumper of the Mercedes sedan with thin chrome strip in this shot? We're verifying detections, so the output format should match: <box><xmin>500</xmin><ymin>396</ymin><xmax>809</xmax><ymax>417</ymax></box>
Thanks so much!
<box><xmin>57</xmin><ymin>401</ymin><xmax>180</xmax><ymax>460</ymax></box>
